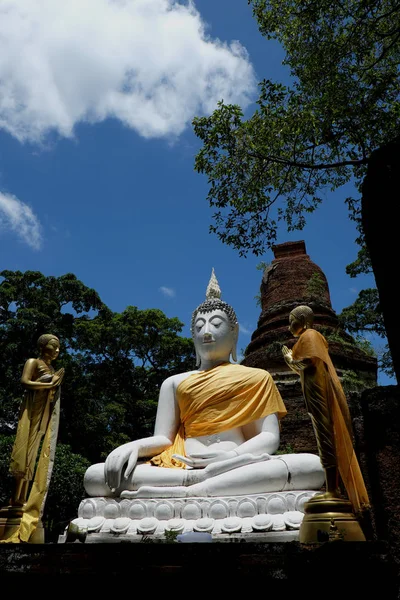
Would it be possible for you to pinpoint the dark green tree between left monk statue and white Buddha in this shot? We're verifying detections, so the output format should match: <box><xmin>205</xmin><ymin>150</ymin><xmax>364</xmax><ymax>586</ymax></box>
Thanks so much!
<box><xmin>60</xmin><ymin>306</ymin><xmax>195</xmax><ymax>462</ymax></box>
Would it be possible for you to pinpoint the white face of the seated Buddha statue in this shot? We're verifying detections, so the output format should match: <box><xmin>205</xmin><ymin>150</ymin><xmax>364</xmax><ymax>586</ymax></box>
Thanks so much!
<box><xmin>193</xmin><ymin>309</ymin><xmax>235</xmax><ymax>360</ymax></box>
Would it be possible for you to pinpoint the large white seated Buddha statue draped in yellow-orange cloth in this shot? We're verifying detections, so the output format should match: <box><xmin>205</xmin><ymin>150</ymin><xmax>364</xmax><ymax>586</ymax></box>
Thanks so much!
<box><xmin>84</xmin><ymin>270</ymin><xmax>324</xmax><ymax>498</ymax></box>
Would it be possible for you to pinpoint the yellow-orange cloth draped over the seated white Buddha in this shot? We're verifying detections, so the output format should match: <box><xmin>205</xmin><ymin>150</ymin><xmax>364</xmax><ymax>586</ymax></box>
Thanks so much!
<box><xmin>150</xmin><ymin>363</ymin><xmax>287</xmax><ymax>469</ymax></box>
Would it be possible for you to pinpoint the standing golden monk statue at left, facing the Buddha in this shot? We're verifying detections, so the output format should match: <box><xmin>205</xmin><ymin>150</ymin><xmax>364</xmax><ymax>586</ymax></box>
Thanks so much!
<box><xmin>0</xmin><ymin>334</ymin><xmax>64</xmax><ymax>543</ymax></box>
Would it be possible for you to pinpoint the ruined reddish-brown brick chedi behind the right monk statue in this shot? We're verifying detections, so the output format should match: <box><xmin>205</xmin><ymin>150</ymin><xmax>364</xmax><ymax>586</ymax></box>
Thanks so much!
<box><xmin>242</xmin><ymin>240</ymin><xmax>377</xmax><ymax>452</ymax></box>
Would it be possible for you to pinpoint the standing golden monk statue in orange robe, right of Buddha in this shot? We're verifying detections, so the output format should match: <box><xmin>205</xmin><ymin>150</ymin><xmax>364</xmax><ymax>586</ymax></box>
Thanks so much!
<box><xmin>282</xmin><ymin>306</ymin><xmax>369</xmax><ymax>514</ymax></box>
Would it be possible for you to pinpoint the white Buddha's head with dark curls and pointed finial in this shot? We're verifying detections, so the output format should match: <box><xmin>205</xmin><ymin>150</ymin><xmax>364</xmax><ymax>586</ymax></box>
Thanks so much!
<box><xmin>191</xmin><ymin>269</ymin><xmax>239</xmax><ymax>366</ymax></box>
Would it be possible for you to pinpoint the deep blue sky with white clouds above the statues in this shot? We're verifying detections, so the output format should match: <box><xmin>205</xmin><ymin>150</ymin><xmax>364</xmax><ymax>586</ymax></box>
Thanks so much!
<box><xmin>0</xmin><ymin>0</ymin><xmax>393</xmax><ymax>385</ymax></box>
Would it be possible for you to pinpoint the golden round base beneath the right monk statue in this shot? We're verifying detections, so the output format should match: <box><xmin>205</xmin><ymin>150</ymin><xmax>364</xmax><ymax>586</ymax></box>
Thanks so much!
<box><xmin>299</xmin><ymin>495</ymin><xmax>366</xmax><ymax>544</ymax></box>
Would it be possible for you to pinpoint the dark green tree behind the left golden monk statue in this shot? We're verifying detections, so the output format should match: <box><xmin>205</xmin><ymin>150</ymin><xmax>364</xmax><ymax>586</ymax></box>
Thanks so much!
<box><xmin>0</xmin><ymin>271</ymin><xmax>106</xmax><ymax>423</ymax></box>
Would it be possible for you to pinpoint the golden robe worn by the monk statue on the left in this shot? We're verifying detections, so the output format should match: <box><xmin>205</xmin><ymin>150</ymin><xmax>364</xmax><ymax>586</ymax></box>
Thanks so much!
<box><xmin>1</xmin><ymin>361</ymin><xmax>60</xmax><ymax>543</ymax></box>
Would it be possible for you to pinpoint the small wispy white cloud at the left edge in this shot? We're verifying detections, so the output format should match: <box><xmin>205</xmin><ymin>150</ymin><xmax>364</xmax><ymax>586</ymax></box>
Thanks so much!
<box><xmin>0</xmin><ymin>192</ymin><xmax>42</xmax><ymax>250</ymax></box>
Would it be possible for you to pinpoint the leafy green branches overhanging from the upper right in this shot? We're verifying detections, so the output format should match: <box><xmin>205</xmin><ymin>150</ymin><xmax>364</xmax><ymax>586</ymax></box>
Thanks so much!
<box><xmin>193</xmin><ymin>0</ymin><xmax>400</xmax><ymax>377</ymax></box>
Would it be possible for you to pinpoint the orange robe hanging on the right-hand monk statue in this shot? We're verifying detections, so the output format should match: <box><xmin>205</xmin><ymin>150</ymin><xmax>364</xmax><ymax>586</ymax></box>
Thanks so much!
<box><xmin>292</xmin><ymin>329</ymin><xmax>369</xmax><ymax>511</ymax></box>
